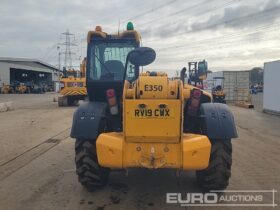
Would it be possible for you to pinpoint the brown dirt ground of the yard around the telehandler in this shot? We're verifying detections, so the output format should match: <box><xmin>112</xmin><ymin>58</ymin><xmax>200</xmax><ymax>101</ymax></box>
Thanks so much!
<box><xmin>0</xmin><ymin>94</ymin><xmax>280</xmax><ymax>210</ymax></box>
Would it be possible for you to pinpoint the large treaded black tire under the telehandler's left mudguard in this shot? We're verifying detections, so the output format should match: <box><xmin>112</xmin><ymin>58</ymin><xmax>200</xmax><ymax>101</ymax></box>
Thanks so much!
<box><xmin>75</xmin><ymin>139</ymin><xmax>110</xmax><ymax>191</ymax></box>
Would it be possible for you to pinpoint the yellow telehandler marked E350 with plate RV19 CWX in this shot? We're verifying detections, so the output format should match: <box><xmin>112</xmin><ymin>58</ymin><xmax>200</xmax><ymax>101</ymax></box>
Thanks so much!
<box><xmin>71</xmin><ymin>24</ymin><xmax>237</xmax><ymax>191</ymax></box>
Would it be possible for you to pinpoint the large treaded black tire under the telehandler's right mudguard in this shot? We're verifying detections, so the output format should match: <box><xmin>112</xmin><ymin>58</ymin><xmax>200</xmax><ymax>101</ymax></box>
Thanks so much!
<box><xmin>196</xmin><ymin>139</ymin><xmax>232</xmax><ymax>191</ymax></box>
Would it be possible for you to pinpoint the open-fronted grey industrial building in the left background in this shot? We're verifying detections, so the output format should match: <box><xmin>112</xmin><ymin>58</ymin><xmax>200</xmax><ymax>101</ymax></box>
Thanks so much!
<box><xmin>0</xmin><ymin>57</ymin><xmax>59</xmax><ymax>89</ymax></box>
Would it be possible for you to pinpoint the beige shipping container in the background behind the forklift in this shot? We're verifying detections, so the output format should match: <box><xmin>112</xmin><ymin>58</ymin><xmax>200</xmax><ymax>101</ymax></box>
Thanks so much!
<box><xmin>204</xmin><ymin>71</ymin><xmax>250</xmax><ymax>102</ymax></box>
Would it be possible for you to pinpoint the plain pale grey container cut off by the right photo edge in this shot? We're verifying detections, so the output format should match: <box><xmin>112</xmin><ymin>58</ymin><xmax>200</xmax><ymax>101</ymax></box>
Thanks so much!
<box><xmin>263</xmin><ymin>60</ymin><xmax>280</xmax><ymax>114</ymax></box>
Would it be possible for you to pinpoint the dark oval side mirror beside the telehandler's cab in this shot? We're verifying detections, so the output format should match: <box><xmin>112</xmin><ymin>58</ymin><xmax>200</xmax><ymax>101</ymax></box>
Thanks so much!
<box><xmin>127</xmin><ymin>47</ymin><xmax>156</xmax><ymax>66</ymax></box>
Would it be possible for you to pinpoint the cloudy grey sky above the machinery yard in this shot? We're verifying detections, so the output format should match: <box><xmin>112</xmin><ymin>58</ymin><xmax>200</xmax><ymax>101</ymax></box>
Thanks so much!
<box><xmin>0</xmin><ymin>0</ymin><xmax>280</xmax><ymax>75</ymax></box>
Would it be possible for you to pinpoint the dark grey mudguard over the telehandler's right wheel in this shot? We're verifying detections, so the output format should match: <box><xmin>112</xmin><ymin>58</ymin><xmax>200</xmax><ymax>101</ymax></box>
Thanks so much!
<box><xmin>200</xmin><ymin>103</ymin><xmax>238</xmax><ymax>139</ymax></box>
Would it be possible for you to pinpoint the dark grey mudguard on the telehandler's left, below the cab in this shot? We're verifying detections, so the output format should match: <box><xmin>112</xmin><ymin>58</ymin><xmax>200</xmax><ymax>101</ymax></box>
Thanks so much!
<box><xmin>70</xmin><ymin>102</ymin><xmax>107</xmax><ymax>140</ymax></box>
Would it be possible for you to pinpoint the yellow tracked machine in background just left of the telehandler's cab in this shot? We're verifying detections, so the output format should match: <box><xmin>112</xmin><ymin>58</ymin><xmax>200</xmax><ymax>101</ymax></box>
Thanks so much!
<box><xmin>58</xmin><ymin>58</ymin><xmax>87</xmax><ymax>106</ymax></box>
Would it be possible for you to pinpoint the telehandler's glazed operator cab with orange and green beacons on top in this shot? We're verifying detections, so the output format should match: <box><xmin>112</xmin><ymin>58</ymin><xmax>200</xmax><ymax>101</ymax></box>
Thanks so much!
<box><xmin>86</xmin><ymin>22</ymin><xmax>140</xmax><ymax>102</ymax></box>
